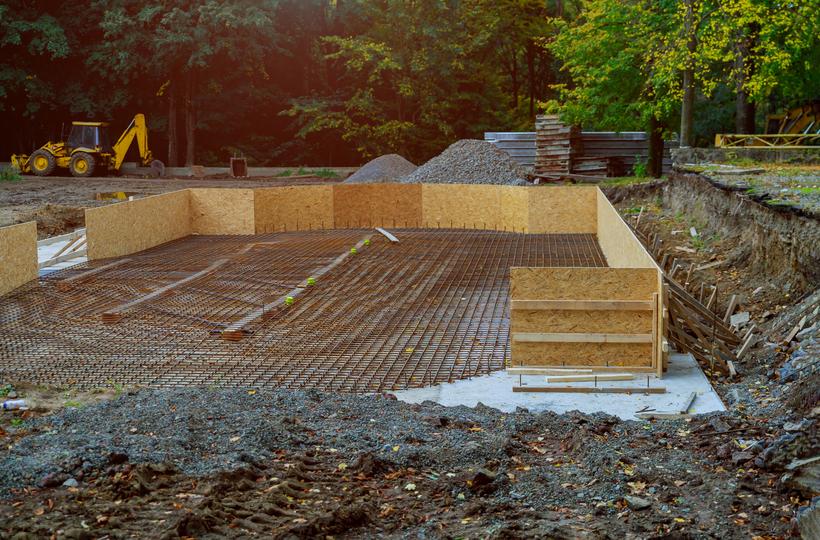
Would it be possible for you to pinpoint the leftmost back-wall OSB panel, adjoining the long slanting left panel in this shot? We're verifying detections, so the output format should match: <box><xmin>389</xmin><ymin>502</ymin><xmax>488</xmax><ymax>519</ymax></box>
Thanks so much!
<box><xmin>191</xmin><ymin>188</ymin><xmax>256</xmax><ymax>234</ymax></box>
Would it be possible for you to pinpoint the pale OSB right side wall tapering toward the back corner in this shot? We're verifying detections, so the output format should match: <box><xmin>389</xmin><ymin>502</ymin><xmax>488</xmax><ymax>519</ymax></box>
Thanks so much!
<box><xmin>594</xmin><ymin>188</ymin><xmax>657</xmax><ymax>268</ymax></box>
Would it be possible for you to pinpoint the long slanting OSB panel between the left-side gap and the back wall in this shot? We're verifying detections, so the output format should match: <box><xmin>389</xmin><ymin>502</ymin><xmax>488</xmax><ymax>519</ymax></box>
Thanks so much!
<box><xmin>85</xmin><ymin>189</ymin><xmax>191</xmax><ymax>260</ymax></box>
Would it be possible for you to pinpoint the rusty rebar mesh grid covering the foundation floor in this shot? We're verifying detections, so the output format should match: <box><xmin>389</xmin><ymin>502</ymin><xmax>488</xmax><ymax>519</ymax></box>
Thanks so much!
<box><xmin>0</xmin><ymin>229</ymin><xmax>606</xmax><ymax>392</ymax></box>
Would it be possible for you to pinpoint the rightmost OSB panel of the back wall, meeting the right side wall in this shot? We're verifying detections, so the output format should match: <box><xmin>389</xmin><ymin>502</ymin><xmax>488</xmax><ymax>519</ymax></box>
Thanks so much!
<box><xmin>527</xmin><ymin>186</ymin><xmax>598</xmax><ymax>234</ymax></box>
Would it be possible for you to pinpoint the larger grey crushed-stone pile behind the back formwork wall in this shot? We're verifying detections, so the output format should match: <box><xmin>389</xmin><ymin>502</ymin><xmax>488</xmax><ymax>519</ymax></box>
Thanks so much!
<box><xmin>402</xmin><ymin>139</ymin><xmax>528</xmax><ymax>186</ymax></box>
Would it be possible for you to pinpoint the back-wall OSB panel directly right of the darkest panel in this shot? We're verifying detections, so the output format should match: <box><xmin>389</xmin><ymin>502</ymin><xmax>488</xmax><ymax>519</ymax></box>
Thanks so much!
<box><xmin>421</xmin><ymin>184</ymin><xmax>503</xmax><ymax>230</ymax></box>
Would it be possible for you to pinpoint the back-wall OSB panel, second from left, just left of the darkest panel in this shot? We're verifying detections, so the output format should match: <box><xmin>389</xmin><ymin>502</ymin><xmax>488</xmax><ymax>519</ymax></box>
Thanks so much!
<box><xmin>254</xmin><ymin>186</ymin><xmax>334</xmax><ymax>234</ymax></box>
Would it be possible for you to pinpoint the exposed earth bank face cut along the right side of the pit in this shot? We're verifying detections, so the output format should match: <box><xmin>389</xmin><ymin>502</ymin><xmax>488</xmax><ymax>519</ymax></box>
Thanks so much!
<box><xmin>605</xmin><ymin>173</ymin><xmax>820</xmax><ymax>293</ymax></box>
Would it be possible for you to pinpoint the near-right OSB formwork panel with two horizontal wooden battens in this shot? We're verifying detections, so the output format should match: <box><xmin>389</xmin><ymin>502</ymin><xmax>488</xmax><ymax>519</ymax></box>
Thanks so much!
<box><xmin>510</xmin><ymin>268</ymin><xmax>658</xmax><ymax>371</ymax></box>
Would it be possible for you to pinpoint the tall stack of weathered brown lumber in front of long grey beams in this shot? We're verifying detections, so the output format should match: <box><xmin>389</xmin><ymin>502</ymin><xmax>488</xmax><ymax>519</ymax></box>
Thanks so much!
<box><xmin>535</xmin><ymin>115</ymin><xmax>582</xmax><ymax>174</ymax></box>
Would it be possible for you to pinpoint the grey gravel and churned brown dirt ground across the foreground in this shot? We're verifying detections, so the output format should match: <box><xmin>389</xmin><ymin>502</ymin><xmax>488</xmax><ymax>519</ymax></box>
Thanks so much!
<box><xmin>0</xmin><ymin>389</ymin><xmax>816</xmax><ymax>538</ymax></box>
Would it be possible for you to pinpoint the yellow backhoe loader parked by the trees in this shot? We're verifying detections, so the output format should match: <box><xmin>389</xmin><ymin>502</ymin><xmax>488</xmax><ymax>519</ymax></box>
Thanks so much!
<box><xmin>11</xmin><ymin>114</ymin><xmax>165</xmax><ymax>178</ymax></box>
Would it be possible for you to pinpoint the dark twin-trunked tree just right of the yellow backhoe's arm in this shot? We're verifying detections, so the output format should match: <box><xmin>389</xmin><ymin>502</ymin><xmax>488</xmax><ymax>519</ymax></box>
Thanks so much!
<box><xmin>90</xmin><ymin>0</ymin><xmax>277</xmax><ymax>166</ymax></box>
